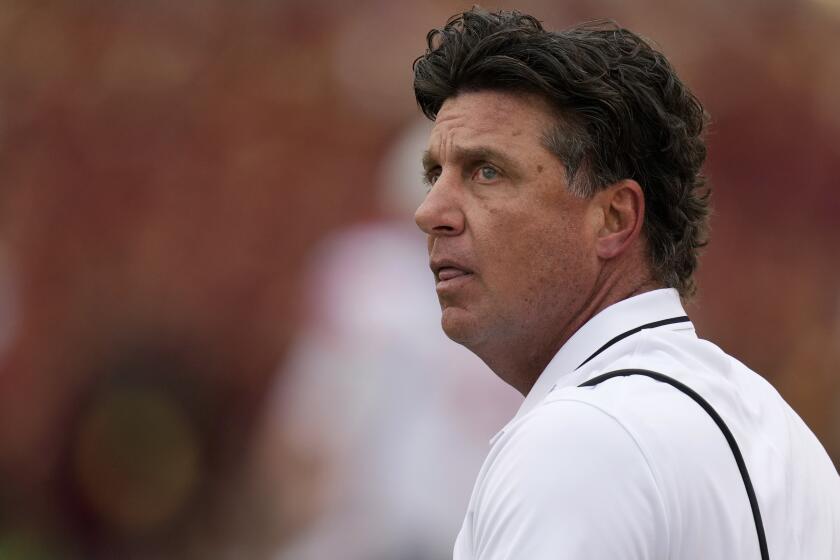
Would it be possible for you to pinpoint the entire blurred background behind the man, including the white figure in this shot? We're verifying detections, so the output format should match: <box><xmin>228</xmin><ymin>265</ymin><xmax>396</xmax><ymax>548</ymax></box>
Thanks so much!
<box><xmin>0</xmin><ymin>0</ymin><xmax>840</xmax><ymax>560</ymax></box>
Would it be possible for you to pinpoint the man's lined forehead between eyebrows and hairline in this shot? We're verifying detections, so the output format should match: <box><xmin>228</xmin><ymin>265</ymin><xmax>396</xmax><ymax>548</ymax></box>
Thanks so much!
<box><xmin>429</xmin><ymin>91</ymin><xmax>555</xmax><ymax>157</ymax></box>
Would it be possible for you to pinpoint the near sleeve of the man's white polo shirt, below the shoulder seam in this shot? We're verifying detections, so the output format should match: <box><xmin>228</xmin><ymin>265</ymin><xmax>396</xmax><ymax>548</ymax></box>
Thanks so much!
<box><xmin>472</xmin><ymin>399</ymin><xmax>667</xmax><ymax>559</ymax></box>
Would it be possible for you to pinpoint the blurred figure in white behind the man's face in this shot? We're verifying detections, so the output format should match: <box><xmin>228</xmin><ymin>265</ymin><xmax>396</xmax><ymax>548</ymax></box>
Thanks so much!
<box><xmin>270</xmin><ymin>122</ymin><xmax>515</xmax><ymax>560</ymax></box>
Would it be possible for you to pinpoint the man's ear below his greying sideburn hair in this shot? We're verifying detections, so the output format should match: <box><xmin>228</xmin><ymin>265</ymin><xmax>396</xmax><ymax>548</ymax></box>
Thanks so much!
<box><xmin>595</xmin><ymin>179</ymin><xmax>645</xmax><ymax>259</ymax></box>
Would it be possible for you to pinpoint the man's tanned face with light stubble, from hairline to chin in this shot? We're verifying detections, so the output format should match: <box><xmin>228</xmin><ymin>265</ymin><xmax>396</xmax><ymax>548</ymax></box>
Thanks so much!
<box><xmin>415</xmin><ymin>91</ymin><xmax>598</xmax><ymax>357</ymax></box>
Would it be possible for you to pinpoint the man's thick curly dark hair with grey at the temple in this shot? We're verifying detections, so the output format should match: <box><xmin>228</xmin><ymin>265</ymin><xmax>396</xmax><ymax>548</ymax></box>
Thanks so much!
<box><xmin>414</xmin><ymin>7</ymin><xmax>709</xmax><ymax>297</ymax></box>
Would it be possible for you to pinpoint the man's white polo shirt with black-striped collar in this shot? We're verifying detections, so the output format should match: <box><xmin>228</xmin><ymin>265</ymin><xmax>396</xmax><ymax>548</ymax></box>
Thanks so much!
<box><xmin>454</xmin><ymin>289</ymin><xmax>840</xmax><ymax>560</ymax></box>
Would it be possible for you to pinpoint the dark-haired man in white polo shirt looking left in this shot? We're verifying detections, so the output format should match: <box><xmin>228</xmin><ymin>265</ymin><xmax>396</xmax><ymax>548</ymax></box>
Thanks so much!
<box><xmin>414</xmin><ymin>9</ymin><xmax>840</xmax><ymax>560</ymax></box>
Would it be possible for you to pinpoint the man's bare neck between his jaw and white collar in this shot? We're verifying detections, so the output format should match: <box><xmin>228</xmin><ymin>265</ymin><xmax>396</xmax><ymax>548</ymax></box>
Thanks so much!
<box><xmin>475</xmin><ymin>275</ymin><xmax>662</xmax><ymax>396</ymax></box>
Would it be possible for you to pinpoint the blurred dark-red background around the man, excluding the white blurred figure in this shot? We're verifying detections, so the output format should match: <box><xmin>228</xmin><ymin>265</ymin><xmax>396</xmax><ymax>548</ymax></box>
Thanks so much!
<box><xmin>0</xmin><ymin>0</ymin><xmax>840</xmax><ymax>558</ymax></box>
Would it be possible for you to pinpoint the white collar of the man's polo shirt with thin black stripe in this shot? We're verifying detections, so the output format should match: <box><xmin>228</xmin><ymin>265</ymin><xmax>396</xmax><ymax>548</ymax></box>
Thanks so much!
<box><xmin>490</xmin><ymin>288</ymin><xmax>694</xmax><ymax>444</ymax></box>
